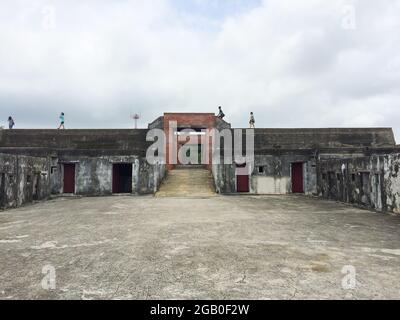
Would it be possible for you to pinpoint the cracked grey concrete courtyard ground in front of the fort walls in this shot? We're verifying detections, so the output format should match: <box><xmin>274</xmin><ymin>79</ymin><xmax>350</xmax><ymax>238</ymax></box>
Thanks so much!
<box><xmin>0</xmin><ymin>196</ymin><xmax>400</xmax><ymax>299</ymax></box>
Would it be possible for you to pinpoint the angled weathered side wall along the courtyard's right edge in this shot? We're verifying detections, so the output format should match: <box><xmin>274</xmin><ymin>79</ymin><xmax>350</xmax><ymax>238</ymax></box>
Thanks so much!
<box><xmin>317</xmin><ymin>154</ymin><xmax>400</xmax><ymax>213</ymax></box>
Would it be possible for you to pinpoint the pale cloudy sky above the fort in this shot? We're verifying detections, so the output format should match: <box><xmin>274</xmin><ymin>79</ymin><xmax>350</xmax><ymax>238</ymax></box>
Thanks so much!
<box><xmin>0</xmin><ymin>0</ymin><xmax>400</xmax><ymax>141</ymax></box>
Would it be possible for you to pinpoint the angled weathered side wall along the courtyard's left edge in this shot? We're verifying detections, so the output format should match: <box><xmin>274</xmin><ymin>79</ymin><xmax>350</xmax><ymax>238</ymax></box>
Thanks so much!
<box><xmin>0</xmin><ymin>154</ymin><xmax>50</xmax><ymax>208</ymax></box>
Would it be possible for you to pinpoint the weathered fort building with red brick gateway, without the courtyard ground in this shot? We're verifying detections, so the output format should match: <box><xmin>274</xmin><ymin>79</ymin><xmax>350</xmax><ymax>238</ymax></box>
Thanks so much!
<box><xmin>0</xmin><ymin>113</ymin><xmax>400</xmax><ymax>213</ymax></box>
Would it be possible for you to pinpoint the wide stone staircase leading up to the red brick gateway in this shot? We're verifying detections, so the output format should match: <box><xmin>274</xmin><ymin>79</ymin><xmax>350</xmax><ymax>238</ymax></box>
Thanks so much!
<box><xmin>156</xmin><ymin>166</ymin><xmax>216</xmax><ymax>198</ymax></box>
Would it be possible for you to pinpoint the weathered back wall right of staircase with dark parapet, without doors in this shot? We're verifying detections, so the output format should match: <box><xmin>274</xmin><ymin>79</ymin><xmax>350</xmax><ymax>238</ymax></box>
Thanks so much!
<box><xmin>212</xmin><ymin>128</ymin><xmax>398</xmax><ymax>195</ymax></box>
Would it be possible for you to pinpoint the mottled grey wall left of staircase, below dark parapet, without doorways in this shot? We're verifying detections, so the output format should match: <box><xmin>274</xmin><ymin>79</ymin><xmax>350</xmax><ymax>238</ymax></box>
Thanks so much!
<box><xmin>0</xmin><ymin>154</ymin><xmax>165</xmax><ymax>208</ymax></box>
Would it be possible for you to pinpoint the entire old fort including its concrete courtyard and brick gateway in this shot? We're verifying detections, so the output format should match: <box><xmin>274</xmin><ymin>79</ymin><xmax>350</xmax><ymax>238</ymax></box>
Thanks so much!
<box><xmin>0</xmin><ymin>113</ymin><xmax>400</xmax><ymax>300</ymax></box>
